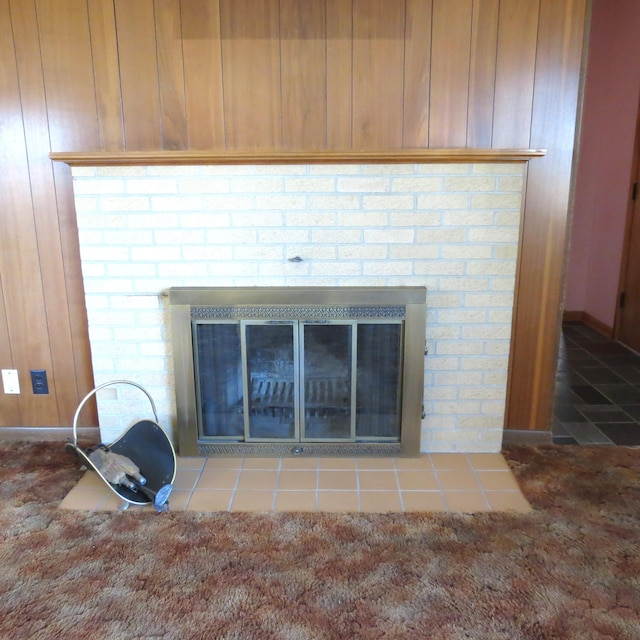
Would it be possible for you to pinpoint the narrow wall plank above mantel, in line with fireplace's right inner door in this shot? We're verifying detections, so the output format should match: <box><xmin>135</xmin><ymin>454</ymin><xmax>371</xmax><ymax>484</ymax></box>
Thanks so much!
<box><xmin>326</xmin><ymin>0</ymin><xmax>353</xmax><ymax>149</ymax></box>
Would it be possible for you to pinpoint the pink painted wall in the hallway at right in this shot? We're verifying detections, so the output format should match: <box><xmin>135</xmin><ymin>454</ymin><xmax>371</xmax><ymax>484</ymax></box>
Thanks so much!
<box><xmin>564</xmin><ymin>0</ymin><xmax>640</xmax><ymax>328</ymax></box>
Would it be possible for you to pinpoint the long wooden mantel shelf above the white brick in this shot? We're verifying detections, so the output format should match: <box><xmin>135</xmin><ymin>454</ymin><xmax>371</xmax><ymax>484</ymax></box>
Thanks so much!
<box><xmin>49</xmin><ymin>148</ymin><xmax>546</xmax><ymax>167</ymax></box>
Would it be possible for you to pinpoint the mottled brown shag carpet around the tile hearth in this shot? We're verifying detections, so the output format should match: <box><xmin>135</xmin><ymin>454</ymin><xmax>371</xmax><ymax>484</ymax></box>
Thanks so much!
<box><xmin>0</xmin><ymin>443</ymin><xmax>640</xmax><ymax>640</ymax></box>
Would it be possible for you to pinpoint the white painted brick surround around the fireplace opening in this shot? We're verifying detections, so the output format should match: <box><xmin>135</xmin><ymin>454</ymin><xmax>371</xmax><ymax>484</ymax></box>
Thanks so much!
<box><xmin>73</xmin><ymin>162</ymin><xmax>524</xmax><ymax>452</ymax></box>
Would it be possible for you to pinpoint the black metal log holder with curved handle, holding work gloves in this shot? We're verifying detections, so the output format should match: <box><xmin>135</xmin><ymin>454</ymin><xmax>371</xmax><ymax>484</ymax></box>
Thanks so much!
<box><xmin>67</xmin><ymin>380</ymin><xmax>176</xmax><ymax>512</ymax></box>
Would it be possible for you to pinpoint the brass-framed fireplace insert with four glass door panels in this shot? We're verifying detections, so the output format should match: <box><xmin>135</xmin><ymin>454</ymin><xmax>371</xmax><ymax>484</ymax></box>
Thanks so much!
<box><xmin>169</xmin><ymin>287</ymin><xmax>426</xmax><ymax>456</ymax></box>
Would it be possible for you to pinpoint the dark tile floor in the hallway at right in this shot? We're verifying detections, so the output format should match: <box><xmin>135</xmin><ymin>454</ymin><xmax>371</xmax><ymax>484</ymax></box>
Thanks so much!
<box><xmin>552</xmin><ymin>323</ymin><xmax>640</xmax><ymax>446</ymax></box>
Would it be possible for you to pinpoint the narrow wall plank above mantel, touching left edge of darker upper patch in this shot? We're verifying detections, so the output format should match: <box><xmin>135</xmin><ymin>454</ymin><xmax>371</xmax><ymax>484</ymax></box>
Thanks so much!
<box><xmin>154</xmin><ymin>0</ymin><xmax>188</xmax><ymax>150</ymax></box>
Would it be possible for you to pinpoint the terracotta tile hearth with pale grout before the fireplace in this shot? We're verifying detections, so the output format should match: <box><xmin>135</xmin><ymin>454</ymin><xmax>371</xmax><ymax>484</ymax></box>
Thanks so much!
<box><xmin>60</xmin><ymin>453</ymin><xmax>531</xmax><ymax>513</ymax></box>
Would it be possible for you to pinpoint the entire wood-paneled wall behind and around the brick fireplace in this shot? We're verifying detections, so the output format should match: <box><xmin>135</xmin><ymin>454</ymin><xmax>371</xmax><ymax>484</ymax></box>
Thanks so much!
<box><xmin>0</xmin><ymin>0</ymin><xmax>587</xmax><ymax>430</ymax></box>
